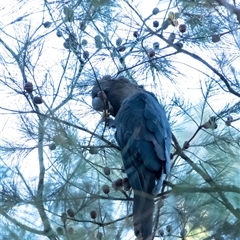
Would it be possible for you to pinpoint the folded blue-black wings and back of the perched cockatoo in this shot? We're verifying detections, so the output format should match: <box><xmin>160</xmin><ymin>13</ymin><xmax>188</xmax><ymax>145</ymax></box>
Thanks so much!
<box><xmin>115</xmin><ymin>92</ymin><xmax>171</xmax><ymax>177</ymax></box>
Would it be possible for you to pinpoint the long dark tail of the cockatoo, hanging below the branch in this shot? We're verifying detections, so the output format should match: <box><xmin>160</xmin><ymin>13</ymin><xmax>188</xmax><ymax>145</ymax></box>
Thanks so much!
<box><xmin>133</xmin><ymin>190</ymin><xmax>154</xmax><ymax>240</ymax></box>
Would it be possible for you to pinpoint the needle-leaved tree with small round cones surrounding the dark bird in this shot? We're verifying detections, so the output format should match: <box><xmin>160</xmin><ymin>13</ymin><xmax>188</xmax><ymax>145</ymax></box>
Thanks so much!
<box><xmin>0</xmin><ymin>0</ymin><xmax>240</xmax><ymax>240</ymax></box>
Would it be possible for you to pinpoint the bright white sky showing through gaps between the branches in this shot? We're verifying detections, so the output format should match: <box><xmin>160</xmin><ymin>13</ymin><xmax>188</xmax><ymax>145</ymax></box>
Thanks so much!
<box><xmin>0</xmin><ymin>0</ymin><xmax>240</xmax><ymax>239</ymax></box>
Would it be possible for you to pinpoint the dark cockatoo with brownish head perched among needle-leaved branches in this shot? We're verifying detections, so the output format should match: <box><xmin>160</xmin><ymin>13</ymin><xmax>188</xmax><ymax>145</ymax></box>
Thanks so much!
<box><xmin>92</xmin><ymin>76</ymin><xmax>171</xmax><ymax>240</ymax></box>
